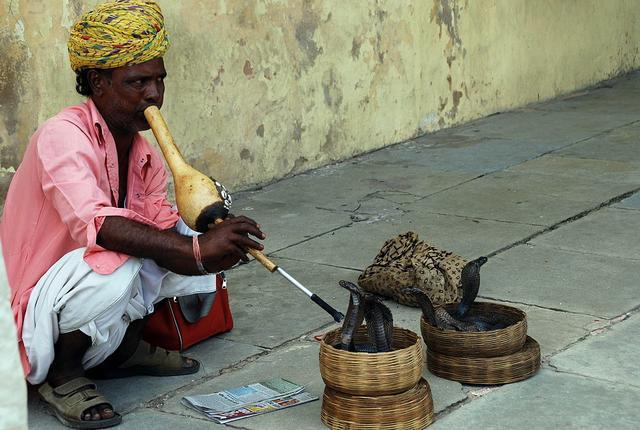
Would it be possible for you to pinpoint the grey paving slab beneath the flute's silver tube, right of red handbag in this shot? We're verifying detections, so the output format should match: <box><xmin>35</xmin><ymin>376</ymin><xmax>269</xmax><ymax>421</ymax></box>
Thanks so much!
<box><xmin>221</xmin><ymin>259</ymin><xmax>357</xmax><ymax>348</ymax></box>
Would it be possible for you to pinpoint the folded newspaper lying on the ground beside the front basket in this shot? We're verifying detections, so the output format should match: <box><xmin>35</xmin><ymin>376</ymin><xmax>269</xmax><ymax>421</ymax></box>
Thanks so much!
<box><xmin>182</xmin><ymin>378</ymin><xmax>318</xmax><ymax>424</ymax></box>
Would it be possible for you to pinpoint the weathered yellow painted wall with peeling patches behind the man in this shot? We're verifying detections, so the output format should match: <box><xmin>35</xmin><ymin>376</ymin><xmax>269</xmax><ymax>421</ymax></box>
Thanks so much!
<box><xmin>0</xmin><ymin>0</ymin><xmax>640</xmax><ymax>200</ymax></box>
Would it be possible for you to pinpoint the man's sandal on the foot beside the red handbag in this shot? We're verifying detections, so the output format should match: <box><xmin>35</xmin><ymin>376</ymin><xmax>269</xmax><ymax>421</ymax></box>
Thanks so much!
<box><xmin>87</xmin><ymin>341</ymin><xmax>200</xmax><ymax>379</ymax></box>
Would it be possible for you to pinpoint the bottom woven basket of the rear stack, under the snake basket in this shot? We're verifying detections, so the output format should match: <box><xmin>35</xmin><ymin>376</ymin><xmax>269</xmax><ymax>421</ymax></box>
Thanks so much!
<box><xmin>427</xmin><ymin>336</ymin><xmax>540</xmax><ymax>385</ymax></box>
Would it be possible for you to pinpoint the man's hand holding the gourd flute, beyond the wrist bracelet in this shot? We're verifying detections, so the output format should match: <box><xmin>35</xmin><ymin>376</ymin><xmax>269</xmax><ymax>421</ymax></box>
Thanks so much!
<box><xmin>198</xmin><ymin>214</ymin><xmax>266</xmax><ymax>272</ymax></box>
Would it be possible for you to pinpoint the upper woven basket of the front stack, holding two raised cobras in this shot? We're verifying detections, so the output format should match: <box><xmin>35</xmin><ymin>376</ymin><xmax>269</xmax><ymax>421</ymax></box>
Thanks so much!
<box><xmin>320</xmin><ymin>326</ymin><xmax>425</xmax><ymax>396</ymax></box>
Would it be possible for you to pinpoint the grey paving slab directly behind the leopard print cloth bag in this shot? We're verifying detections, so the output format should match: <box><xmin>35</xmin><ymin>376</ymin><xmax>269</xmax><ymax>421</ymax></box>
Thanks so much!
<box><xmin>274</xmin><ymin>211</ymin><xmax>540</xmax><ymax>270</ymax></box>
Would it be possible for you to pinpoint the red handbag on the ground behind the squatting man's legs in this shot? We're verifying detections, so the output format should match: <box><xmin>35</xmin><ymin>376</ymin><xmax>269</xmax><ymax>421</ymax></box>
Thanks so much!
<box><xmin>143</xmin><ymin>272</ymin><xmax>233</xmax><ymax>351</ymax></box>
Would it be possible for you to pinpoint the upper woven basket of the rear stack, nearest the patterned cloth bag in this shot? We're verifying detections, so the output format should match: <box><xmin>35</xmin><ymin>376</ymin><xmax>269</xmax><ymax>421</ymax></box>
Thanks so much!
<box><xmin>420</xmin><ymin>302</ymin><xmax>527</xmax><ymax>357</ymax></box>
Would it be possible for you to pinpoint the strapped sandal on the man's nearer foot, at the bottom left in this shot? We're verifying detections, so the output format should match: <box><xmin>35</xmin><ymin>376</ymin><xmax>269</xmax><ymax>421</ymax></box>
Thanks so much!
<box><xmin>38</xmin><ymin>376</ymin><xmax>122</xmax><ymax>429</ymax></box>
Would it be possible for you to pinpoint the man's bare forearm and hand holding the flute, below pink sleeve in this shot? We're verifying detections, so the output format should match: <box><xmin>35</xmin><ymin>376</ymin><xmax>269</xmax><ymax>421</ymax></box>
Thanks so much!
<box><xmin>97</xmin><ymin>216</ymin><xmax>265</xmax><ymax>275</ymax></box>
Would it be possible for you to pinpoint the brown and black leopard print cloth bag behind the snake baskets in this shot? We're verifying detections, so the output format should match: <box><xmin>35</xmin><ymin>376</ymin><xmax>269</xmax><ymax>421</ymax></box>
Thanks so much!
<box><xmin>358</xmin><ymin>231</ymin><xmax>467</xmax><ymax>307</ymax></box>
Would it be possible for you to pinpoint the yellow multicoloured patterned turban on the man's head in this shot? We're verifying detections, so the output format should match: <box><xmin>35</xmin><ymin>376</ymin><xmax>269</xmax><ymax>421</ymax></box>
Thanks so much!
<box><xmin>67</xmin><ymin>0</ymin><xmax>169</xmax><ymax>72</ymax></box>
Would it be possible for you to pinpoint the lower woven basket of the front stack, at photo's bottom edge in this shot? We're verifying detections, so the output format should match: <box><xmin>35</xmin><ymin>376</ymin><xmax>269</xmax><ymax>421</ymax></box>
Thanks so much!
<box><xmin>321</xmin><ymin>379</ymin><xmax>433</xmax><ymax>430</ymax></box>
